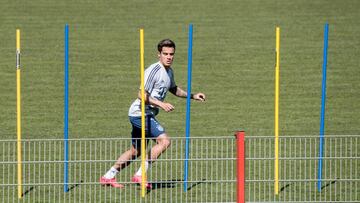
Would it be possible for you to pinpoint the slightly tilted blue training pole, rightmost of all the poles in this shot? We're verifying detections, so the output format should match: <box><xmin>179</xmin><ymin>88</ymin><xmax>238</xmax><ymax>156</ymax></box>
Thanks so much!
<box><xmin>318</xmin><ymin>23</ymin><xmax>329</xmax><ymax>192</ymax></box>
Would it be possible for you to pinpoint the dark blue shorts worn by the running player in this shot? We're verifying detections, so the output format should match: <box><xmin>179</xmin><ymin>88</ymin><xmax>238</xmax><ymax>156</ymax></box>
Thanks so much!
<box><xmin>129</xmin><ymin>116</ymin><xmax>165</xmax><ymax>149</ymax></box>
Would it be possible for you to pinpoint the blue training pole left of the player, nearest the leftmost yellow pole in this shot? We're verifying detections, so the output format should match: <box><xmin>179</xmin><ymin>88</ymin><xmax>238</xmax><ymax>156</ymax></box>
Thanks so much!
<box><xmin>64</xmin><ymin>24</ymin><xmax>69</xmax><ymax>192</ymax></box>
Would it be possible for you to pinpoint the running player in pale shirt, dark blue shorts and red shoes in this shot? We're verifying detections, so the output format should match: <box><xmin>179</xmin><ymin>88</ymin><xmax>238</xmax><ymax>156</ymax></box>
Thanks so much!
<box><xmin>100</xmin><ymin>39</ymin><xmax>205</xmax><ymax>189</ymax></box>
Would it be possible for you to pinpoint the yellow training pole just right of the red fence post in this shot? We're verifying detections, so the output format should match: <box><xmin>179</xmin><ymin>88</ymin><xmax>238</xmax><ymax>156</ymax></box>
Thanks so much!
<box><xmin>275</xmin><ymin>27</ymin><xmax>280</xmax><ymax>195</ymax></box>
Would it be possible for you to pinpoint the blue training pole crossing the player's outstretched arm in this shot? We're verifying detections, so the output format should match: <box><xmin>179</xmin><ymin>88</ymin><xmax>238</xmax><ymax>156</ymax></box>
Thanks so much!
<box><xmin>184</xmin><ymin>24</ymin><xmax>193</xmax><ymax>192</ymax></box>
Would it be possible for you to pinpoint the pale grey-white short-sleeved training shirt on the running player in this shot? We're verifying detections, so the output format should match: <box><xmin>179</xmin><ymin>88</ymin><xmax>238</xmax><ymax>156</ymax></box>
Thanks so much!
<box><xmin>129</xmin><ymin>62</ymin><xmax>176</xmax><ymax>117</ymax></box>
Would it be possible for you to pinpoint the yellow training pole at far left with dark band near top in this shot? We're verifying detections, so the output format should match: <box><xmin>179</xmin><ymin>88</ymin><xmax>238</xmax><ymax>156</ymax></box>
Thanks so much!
<box><xmin>16</xmin><ymin>29</ymin><xmax>22</xmax><ymax>199</ymax></box>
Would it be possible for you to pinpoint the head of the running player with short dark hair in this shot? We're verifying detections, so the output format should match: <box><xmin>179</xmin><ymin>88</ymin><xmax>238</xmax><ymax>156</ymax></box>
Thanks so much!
<box><xmin>158</xmin><ymin>39</ymin><xmax>175</xmax><ymax>68</ymax></box>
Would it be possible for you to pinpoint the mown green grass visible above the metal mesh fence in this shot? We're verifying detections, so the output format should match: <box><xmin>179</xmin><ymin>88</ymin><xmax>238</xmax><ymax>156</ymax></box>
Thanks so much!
<box><xmin>0</xmin><ymin>0</ymin><xmax>360</xmax><ymax>202</ymax></box>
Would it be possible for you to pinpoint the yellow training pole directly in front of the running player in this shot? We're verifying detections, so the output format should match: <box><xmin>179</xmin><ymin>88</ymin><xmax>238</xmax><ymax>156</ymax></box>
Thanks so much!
<box><xmin>140</xmin><ymin>29</ymin><xmax>146</xmax><ymax>197</ymax></box>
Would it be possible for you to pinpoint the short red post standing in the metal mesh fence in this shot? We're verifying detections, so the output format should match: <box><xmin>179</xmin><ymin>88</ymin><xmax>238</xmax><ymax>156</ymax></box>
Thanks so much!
<box><xmin>235</xmin><ymin>131</ymin><xmax>245</xmax><ymax>203</ymax></box>
